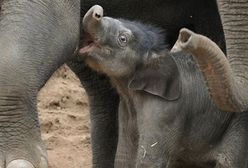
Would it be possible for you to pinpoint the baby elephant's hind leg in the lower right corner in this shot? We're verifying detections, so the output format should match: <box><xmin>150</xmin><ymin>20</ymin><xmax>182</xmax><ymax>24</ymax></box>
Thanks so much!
<box><xmin>213</xmin><ymin>113</ymin><xmax>248</xmax><ymax>168</ymax></box>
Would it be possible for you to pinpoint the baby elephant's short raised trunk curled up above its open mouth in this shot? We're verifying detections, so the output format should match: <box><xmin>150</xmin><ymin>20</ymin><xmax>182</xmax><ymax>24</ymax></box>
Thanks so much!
<box><xmin>83</xmin><ymin>5</ymin><xmax>103</xmax><ymax>37</ymax></box>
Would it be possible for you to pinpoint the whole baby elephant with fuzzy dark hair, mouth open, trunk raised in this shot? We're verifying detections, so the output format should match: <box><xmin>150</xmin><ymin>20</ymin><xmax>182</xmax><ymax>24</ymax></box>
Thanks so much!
<box><xmin>79</xmin><ymin>5</ymin><xmax>248</xmax><ymax>168</ymax></box>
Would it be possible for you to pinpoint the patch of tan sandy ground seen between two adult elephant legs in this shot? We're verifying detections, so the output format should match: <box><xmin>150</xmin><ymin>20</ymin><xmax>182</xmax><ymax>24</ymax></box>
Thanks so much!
<box><xmin>38</xmin><ymin>66</ymin><xmax>91</xmax><ymax>168</ymax></box>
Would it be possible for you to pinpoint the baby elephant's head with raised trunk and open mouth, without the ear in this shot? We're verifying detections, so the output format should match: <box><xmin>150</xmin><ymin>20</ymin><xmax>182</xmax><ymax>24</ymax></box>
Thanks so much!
<box><xmin>79</xmin><ymin>5</ymin><xmax>166</xmax><ymax>77</ymax></box>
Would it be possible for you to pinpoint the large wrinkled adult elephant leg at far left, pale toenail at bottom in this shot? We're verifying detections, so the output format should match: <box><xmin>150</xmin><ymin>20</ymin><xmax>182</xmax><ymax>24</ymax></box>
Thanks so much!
<box><xmin>0</xmin><ymin>0</ymin><xmax>80</xmax><ymax>168</ymax></box>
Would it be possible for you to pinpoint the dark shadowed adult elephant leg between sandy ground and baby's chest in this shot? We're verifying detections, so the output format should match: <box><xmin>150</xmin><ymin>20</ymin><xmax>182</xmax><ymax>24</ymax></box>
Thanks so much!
<box><xmin>68</xmin><ymin>60</ymin><xmax>119</xmax><ymax>168</ymax></box>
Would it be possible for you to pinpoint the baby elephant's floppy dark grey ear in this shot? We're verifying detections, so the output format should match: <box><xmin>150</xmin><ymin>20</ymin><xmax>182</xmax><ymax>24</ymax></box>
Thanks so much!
<box><xmin>128</xmin><ymin>52</ymin><xmax>181</xmax><ymax>101</ymax></box>
